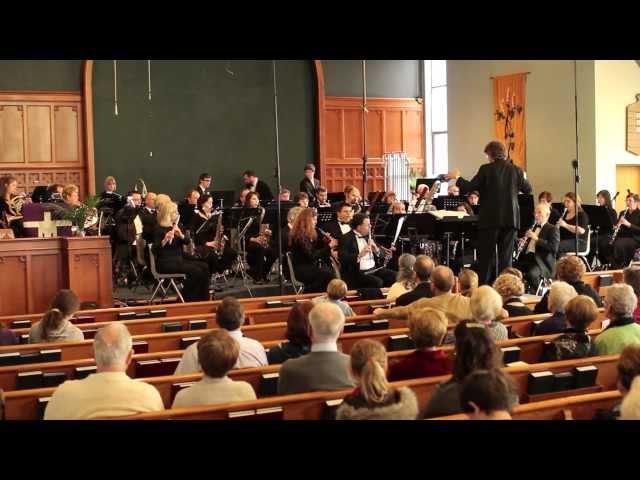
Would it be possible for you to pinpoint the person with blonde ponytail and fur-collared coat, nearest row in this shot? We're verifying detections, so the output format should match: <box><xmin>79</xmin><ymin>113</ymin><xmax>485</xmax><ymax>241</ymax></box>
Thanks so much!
<box><xmin>336</xmin><ymin>340</ymin><xmax>418</xmax><ymax>420</ymax></box>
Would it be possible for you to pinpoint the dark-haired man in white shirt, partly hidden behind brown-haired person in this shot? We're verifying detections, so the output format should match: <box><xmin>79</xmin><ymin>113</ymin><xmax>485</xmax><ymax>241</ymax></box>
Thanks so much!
<box><xmin>175</xmin><ymin>297</ymin><xmax>268</xmax><ymax>375</ymax></box>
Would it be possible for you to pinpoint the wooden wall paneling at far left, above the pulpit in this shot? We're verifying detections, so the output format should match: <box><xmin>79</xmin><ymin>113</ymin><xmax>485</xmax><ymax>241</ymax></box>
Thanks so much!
<box><xmin>0</xmin><ymin>92</ymin><xmax>88</xmax><ymax>197</ymax></box>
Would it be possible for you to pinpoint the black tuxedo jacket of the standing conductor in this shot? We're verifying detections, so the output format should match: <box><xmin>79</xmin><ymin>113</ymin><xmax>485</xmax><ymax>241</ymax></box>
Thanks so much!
<box><xmin>456</xmin><ymin>160</ymin><xmax>531</xmax><ymax>229</ymax></box>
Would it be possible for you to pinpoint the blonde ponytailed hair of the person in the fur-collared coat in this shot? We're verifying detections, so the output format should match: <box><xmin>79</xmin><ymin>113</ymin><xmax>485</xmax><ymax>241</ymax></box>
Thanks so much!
<box><xmin>351</xmin><ymin>339</ymin><xmax>389</xmax><ymax>404</ymax></box>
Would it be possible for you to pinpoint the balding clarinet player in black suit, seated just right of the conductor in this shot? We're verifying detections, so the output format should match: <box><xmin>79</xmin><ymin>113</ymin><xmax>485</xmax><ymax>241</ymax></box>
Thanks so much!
<box><xmin>515</xmin><ymin>203</ymin><xmax>560</xmax><ymax>293</ymax></box>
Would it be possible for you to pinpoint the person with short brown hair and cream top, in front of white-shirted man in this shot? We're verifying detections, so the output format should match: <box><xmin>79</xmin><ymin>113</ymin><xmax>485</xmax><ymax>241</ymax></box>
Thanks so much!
<box><xmin>172</xmin><ymin>329</ymin><xmax>256</xmax><ymax>408</ymax></box>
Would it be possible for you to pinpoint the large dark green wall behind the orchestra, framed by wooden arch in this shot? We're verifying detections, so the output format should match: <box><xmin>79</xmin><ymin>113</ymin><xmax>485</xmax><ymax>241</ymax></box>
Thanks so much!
<box><xmin>93</xmin><ymin>60</ymin><xmax>316</xmax><ymax>198</ymax></box>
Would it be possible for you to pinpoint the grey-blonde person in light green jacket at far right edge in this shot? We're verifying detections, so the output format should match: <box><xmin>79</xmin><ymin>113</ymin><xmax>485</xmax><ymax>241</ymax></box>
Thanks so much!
<box><xmin>596</xmin><ymin>283</ymin><xmax>640</xmax><ymax>355</ymax></box>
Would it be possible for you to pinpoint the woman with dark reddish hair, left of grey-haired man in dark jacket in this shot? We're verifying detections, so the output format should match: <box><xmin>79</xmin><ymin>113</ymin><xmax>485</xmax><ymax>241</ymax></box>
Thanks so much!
<box><xmin>267</xmin><ymin>302</ymin><xmax>314</xmax><ymax>365</ymax></box>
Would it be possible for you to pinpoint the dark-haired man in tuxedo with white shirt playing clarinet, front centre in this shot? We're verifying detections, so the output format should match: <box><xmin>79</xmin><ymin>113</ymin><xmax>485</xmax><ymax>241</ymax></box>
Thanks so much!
<box><xmin>338</xmin><ymin>213</ymin><xmax>396</xmax><ymax>288</ymax></box>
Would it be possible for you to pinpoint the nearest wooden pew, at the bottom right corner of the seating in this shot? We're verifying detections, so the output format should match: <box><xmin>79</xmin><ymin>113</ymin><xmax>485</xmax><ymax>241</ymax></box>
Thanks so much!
<box><xmin>429</xmin><ymin>390</ymin><xmax>622</xmax><ymax>420</ymax></box>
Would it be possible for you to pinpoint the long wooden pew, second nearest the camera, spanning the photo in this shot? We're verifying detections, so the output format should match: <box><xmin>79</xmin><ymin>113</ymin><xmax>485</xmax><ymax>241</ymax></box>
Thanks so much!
<box><xmin>5</xmin><ymin>337</ymin><xmax>619</xmax><ymax>419</ymax></box>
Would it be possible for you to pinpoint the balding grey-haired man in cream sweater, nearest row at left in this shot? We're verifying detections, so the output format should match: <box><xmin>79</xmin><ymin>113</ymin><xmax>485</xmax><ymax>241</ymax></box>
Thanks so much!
<box><xmin>44</xmin><ymin>322</ymin><xmax>164</xmax><ymax>420</ymax></box>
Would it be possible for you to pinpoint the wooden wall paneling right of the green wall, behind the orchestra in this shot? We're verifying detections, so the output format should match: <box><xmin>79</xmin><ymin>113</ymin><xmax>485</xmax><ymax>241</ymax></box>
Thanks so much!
<box><xmin>319</xmin><ymin>97</ymin><xmax>424</xmax><ymax>192</ymax></box>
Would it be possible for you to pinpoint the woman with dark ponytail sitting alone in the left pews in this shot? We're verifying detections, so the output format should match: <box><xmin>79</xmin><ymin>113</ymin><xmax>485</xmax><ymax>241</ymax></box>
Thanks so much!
<box><xmin>29</xmin><ymin>290</ymin><xmax>84</xmax><ymax>343</ymax></box>
